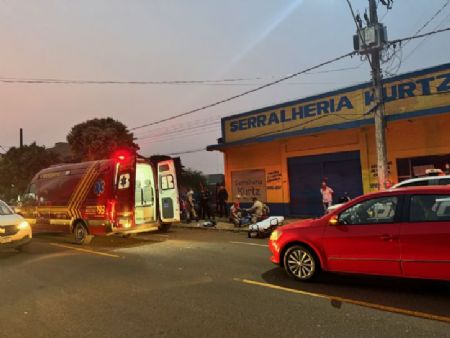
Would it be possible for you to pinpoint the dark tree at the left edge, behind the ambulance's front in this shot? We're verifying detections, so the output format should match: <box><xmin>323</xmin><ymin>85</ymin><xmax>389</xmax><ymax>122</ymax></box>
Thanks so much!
<box><xmin>0</xmin><ymin>143</ymin><xmax>59</xmax><ymax>201</ymax></box>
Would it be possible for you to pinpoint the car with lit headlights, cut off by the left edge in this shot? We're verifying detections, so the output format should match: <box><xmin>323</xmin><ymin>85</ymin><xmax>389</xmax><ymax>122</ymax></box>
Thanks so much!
<box><xmin>0</xmin><ymin>200</ymin><xmax>33</xmax><ymax>250</ymax></box>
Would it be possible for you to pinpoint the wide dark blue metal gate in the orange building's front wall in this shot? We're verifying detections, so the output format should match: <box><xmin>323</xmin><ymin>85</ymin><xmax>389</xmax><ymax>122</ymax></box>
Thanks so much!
<box><xmin>288</xmin><ymin>151</ymin><xmax>363</xmax><ymax>216</ymax></box>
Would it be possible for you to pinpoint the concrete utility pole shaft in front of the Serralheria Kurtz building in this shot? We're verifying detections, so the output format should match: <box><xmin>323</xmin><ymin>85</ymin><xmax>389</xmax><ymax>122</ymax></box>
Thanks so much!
<box><xmin>369</xmin><ymin>0</ymin><xmax>389</xmax><ymax>190</ymax></box>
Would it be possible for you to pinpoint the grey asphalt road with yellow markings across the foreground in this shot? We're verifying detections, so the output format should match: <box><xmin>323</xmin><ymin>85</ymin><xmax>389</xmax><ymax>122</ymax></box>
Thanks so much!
<box><xmin>0</xmin><ymin>229</ymin><xmax>450</xmax><ymax>338</ymax></box>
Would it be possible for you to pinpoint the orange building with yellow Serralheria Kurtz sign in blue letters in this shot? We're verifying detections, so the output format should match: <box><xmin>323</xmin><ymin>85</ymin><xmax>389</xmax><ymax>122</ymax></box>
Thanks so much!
<box><xmin>207</xmin><ymin>63</ymin><xmax>450</xmax><ymax>216</ymax></box>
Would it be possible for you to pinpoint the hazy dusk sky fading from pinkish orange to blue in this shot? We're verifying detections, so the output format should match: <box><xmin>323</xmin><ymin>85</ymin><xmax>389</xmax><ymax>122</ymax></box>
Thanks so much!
<box><xmin>0</xmin><ymin>0</ymin><xmax>450</xmax><ymax>173</ymax></box>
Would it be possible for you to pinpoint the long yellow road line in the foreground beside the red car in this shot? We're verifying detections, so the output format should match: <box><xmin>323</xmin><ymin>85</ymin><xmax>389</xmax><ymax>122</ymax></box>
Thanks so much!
<box><xmin>234</xmin><ymin>278</ymin><xmax>450</xmax><ymax>323</ymax></box>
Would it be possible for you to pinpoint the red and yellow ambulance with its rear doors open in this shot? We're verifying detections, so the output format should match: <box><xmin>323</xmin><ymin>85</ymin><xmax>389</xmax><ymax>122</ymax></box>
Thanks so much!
<box><xmin>18</xmin><ymin>152</ymin><xmax>180</xmax><ymax>244</ymax></box>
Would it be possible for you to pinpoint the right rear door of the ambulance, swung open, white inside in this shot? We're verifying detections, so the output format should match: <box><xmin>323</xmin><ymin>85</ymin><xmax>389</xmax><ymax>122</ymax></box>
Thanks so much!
<box><xmin>157</xmin><ymin>160</ymin><xmax>180</xmax><ymax>223</ymax></box>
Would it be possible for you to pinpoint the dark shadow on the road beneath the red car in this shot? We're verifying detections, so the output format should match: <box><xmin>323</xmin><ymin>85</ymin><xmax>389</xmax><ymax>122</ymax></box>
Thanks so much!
<box><xmin>262</xmin><ymin>268</ymin><xmax>450</xmax><ymax>316</ymax></box>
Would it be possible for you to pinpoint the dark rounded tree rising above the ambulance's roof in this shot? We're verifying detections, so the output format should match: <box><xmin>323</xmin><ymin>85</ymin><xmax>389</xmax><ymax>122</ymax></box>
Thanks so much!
<box><xmin>67</xmin><ymin>117</ymin><xmax>139</xmax><ymax>161</ymax></box>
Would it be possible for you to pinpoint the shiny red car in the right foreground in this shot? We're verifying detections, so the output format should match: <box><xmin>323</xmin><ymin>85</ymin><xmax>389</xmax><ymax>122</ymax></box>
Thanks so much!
<box><xmin>269</xmin><ymin>187</ymin><xmax>450</xmax><ymax>281</ymax></box>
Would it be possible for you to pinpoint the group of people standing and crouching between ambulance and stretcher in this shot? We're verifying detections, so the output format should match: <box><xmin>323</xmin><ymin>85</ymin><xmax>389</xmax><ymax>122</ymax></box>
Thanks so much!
<box><xmin>182</xmin><ymin>185</ymin><xmax>269</xmax><ymax>226</ymax></box>
